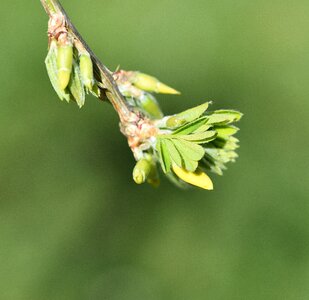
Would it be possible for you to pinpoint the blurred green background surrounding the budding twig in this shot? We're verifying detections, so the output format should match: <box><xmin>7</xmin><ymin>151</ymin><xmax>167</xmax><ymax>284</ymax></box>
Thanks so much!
<box><xmin>0</xmin><ymin>0</ymin><xmax>309</xmax><ymax>300</ymax></box>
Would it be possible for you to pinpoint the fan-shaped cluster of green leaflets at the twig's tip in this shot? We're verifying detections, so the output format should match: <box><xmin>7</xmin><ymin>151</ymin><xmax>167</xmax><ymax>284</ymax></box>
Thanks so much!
<box><xmin>156</xmin><ymin>102</ymin><xmax>242</xmax><ymax>182</ymax></box>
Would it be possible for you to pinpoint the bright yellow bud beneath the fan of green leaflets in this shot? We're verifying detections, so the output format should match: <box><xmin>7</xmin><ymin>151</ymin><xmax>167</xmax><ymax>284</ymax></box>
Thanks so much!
<box><xmin>172</xmin><ymin>164</ymin><xmax>213</xmax><ymax>190</ymax></box>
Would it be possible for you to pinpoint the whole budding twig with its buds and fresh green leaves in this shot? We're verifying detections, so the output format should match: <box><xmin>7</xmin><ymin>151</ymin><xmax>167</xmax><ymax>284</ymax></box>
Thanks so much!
<box><xmin>41</xmin><ymin>0</ymin><xmax>242</xmax><ymax>190</ymax></box>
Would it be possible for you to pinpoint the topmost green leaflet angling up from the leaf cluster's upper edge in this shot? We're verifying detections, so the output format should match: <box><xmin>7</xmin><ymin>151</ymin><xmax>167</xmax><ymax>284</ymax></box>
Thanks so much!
<box><xmin>166</xmin><ymin>102</ymin><xmax>209</xmax><ymax>128</ymax></box>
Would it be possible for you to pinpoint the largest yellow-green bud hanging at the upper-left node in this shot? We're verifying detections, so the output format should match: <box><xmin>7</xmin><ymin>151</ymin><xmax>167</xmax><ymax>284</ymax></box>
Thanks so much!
<box><xmin>57</xmin><ymin>44</ymin><xmax>73</xmax><ymax>90</ymax></box>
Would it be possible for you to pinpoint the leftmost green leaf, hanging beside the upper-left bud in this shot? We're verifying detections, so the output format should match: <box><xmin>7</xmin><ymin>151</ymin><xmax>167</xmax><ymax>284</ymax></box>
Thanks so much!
<box><xmin>45</xmin><ymin>40</ymin><xmax>71</xmax><ymax>102</ymax></box>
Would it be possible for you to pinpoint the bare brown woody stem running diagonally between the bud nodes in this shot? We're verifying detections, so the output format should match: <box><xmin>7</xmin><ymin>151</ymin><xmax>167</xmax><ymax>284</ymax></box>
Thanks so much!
<box><xmin>40</xmin><ymin>0</ymin><xmax>137</xmax><ymax>123</ymax></box>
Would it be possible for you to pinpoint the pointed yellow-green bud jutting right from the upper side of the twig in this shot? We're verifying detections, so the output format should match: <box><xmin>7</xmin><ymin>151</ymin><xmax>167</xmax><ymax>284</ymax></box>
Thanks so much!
<box><xmin>130</xmin><ymin>72</ymin><xmax>180</xmax><ymax>95</ymax></box>
